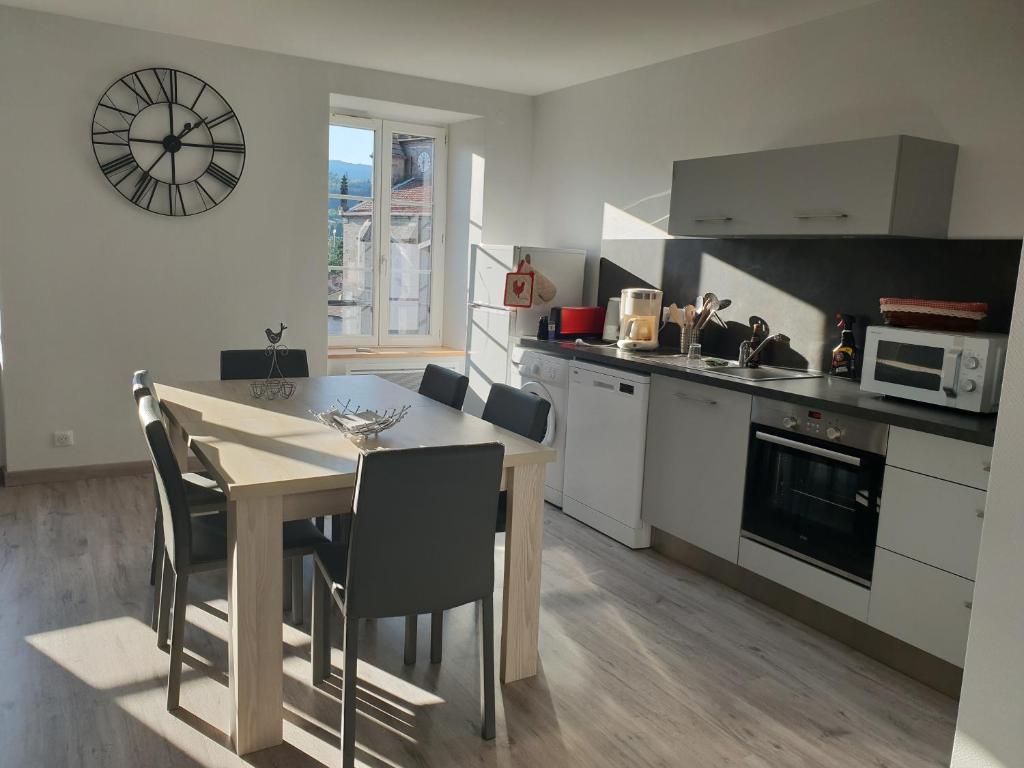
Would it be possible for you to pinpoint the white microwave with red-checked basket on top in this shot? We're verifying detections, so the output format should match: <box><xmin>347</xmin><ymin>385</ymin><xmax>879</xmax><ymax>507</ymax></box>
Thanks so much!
<box><xmin>860</xmin><ymin>326</ymin><xmax>1007</xmax><ymax>414</ymax></box>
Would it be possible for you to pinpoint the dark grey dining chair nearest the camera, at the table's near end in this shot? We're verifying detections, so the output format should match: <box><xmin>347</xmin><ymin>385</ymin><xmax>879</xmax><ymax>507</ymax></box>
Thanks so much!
<box><xmin>310</xmin><ymin>442</ymin><xmax>505</xmax><ymax>768</ymax></box>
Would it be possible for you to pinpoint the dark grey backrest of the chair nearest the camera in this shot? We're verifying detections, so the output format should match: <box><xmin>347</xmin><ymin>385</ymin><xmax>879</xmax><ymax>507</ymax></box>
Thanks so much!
<box><xmin>345</xmin><ymin>442</ymin><xmax>505</xmax><ymax>618</ymax></box>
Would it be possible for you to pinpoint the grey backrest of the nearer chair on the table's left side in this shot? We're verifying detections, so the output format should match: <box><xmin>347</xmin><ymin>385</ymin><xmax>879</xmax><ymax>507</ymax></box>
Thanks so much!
<box><xmin>138</xmin><ymin>394</ymin><xmax>191</xmax><ymax>572</ymax></box>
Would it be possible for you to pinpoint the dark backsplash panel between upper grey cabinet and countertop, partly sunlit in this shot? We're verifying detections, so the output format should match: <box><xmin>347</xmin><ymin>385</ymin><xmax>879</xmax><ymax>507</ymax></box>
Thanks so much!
<box><xmin>598</xmin><ymin>238</ymin><xmax>1021</xmax><ymax>370</ymax></box>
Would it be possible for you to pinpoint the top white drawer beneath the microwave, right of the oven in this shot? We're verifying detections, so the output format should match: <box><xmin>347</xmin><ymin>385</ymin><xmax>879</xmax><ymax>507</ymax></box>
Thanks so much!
<box><xmin>886</xmin><ymin>427</ymin><xmax>992</xmax><ymax>489</ymax></box>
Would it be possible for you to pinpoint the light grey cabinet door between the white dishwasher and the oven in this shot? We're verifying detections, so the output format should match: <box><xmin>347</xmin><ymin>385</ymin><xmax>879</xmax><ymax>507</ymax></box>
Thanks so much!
<box><xmin>641</xmin><ymin>375</ymin><xmax>753</xmax><ymax>562</ymax></box>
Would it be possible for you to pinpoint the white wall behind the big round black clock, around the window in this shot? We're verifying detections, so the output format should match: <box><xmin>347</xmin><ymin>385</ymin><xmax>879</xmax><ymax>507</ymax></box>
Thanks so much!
<box><xmin>0</xmin><ymin>6</ymin><xmax>532</xmax><ymax>471</ymax></box>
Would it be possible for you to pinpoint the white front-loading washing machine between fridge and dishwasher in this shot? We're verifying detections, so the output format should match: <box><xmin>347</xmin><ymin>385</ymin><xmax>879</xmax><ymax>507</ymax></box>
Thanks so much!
<box><xmin>512</xmin><ymin>349</ymin><xmax>570</xmax><ymax>507</ymax></box>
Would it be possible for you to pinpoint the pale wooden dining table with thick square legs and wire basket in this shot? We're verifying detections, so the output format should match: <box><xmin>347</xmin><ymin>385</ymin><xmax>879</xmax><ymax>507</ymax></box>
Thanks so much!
<box><xmin>155</xmin><ymin>376</ymin><xmax>555</xmax><ymax>755</ymax></box>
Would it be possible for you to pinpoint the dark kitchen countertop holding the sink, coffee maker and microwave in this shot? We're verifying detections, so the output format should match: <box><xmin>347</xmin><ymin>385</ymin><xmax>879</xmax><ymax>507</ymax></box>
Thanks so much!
<box><xmin>519</xmin><ymin>337</ymin><xmax>995</xmax><ymax>445</ymax></box>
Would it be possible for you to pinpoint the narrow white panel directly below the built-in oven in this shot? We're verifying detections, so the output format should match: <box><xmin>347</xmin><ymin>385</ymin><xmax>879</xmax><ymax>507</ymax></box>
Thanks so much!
<box><xmin>739</xmin><ymin>539</ymin><xmax>870</xmax><ymax>622</ymax></box>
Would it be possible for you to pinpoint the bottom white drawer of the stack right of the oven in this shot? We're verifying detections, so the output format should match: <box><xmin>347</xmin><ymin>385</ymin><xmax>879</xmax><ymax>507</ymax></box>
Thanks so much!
<box><xmin>867</xmin><ymin>548</ymin><xmax>974</xmax><ymax>667</ymax></box>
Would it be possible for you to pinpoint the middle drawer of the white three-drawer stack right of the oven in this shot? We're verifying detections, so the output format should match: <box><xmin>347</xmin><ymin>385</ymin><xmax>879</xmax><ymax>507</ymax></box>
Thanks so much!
<box><xmin>878</xmin><ymin>467</ymin><xmax>985</xmax><ymax>581</ymax></box>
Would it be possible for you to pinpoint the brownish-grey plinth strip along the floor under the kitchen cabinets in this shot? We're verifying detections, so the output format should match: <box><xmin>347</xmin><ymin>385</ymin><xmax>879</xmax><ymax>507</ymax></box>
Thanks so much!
<box><xmin>650</xmin><ymin>528</ymin><xmax>964</xmax><ymax>698</ymax></box>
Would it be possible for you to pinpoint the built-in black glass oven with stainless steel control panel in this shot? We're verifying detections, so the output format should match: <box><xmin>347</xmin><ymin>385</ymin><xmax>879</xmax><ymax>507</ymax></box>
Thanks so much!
<box><xmin>740</xmin><ymin>397</ymin><xmax>889</xmax><ymax>587</ymax></box>
